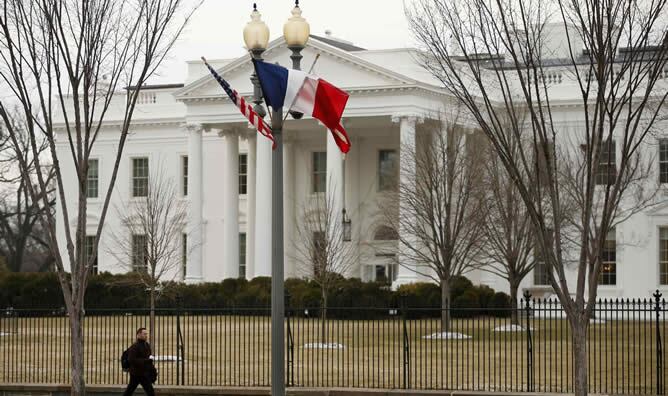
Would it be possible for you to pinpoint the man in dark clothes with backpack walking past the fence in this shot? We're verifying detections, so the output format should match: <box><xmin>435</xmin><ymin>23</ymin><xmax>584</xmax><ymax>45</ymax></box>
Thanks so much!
<box><xmin>123</xmin><ymin>327</ymin><xmax>155</xmax><ymax>396</ymax></box>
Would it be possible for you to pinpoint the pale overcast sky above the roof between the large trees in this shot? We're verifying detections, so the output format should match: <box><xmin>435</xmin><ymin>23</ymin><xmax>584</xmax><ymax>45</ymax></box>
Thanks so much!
<box><xmin>151</xmin><ymin>0</ymin><xmax>413</xmax><ymax>83</ymax></box>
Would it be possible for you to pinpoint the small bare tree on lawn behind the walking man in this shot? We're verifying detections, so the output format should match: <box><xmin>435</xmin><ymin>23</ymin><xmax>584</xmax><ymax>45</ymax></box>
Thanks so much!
<box><xmin>109</xmin><ymin>165</ymin><xmax>187</xmax><ymax>350</ymax></box>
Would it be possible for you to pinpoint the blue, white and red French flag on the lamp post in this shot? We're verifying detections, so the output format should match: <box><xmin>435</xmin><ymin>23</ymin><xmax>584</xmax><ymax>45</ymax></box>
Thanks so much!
<box><xmin>253</xmin><ymin>59</ymin><xmax>350</xmax><ymax>153</ymax></box>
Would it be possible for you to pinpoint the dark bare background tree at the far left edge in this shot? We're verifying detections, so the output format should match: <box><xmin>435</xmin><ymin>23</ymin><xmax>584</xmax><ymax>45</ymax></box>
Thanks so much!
<box><xmin>0</xmin><ymin>114</ymin><xmax>55</xmax><ymax>271</ymax></box>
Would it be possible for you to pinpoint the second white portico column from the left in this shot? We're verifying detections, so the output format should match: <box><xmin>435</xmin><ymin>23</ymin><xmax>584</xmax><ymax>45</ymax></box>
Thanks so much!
<box><xmin>222</xmin><ymin>130</ymin><xmax>239</xmax><ymax>278</ymax></box>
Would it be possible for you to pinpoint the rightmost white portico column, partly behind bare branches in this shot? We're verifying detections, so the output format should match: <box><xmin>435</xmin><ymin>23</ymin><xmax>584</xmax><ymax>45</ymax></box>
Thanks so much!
<box><xmin>392</xmin><ymin>116</ymin><xmax>418</xmax><ymax>288</ymax></box>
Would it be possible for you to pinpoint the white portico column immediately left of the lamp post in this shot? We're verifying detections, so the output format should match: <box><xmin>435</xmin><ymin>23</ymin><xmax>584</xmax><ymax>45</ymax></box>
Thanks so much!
<box><xmin>253</xmin><ymin>133</ymin><xmax>271</xmax><ymax>276</ymax></box>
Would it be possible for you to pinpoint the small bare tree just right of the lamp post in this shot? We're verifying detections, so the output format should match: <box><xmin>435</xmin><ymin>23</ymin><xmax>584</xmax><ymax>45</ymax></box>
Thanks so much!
<box><xmin>293</xmin><ymin>183</ymin><xmax>356</xmax><ymax>344</ymax></box>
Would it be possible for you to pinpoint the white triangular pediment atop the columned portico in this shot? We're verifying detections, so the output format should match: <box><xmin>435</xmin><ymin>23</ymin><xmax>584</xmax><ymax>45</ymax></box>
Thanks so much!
<box><xmin>174</xmin><ymin>38</ymin><xmax>416</xmax><ymax>100</ymax></box>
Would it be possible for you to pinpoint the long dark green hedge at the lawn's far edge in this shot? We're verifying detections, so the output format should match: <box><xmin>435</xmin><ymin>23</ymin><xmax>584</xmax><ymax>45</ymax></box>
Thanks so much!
<box><xmin>0</xmin><ymin>272</ymin><xmax>510</xmax><ymax>319</ymax></box>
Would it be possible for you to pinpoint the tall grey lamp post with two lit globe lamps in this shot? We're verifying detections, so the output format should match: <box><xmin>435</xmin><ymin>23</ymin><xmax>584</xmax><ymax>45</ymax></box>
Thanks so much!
<box><xmin>244</xmin><ymin>0</ymin><xmax>310</xmax><ymax>396</ymax></box>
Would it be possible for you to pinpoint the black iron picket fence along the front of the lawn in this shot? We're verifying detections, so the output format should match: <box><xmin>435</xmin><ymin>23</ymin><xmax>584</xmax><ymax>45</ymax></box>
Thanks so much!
<box><xmin>0</xmin><ymin>292</ymin><xmax>668</xmax><ymax>395</ymax></box>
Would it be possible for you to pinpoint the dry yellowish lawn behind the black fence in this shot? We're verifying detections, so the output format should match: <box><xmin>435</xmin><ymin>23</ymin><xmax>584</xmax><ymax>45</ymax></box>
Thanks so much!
<box><xmin>0</xmin><ymin>316</ymin><xmax>668</xmax><ymax>394</ymax></box>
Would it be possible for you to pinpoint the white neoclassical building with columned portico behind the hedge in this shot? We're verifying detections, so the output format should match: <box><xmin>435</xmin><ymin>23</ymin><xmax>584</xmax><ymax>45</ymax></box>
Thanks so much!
<box><xmin>59</xmin><ymin>31</ymin><xmax>668</xmax><ymax>297</ymax></box>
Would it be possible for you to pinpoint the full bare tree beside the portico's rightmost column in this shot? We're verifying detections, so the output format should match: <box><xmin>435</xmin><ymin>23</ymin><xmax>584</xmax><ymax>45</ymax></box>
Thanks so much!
<box><xmin>383</xmin><ymin>114</ymin><xmax>484</xmax><ymax>332</ymax></box>
